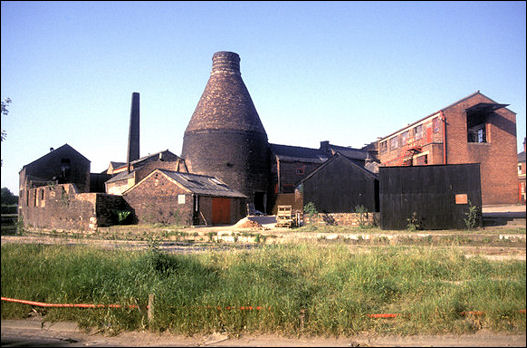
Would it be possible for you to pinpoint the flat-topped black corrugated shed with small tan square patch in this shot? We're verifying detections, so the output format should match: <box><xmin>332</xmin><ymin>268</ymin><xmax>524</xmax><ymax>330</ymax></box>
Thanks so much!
<box><xmin>379</xmin><ymin>163</ymin><xmax>481</xmax><ymax>230</ymax></box>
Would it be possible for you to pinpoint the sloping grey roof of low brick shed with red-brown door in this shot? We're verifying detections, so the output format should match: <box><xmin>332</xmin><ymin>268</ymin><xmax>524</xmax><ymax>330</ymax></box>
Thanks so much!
<box><xmin>156</xmin><ymin>169</ymin><xmax>247</xmax><ymax>198</ymax></box>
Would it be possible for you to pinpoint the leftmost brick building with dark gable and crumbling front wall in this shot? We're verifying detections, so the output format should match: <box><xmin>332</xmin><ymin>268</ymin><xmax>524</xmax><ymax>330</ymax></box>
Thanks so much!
<box><xmin>18</xmin><ymin>144</ymin><xmax>133</xmax><ymax>230</ymax></box>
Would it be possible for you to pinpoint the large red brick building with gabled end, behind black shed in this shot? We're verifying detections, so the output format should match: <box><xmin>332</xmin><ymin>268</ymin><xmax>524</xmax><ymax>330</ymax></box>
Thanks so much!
<box><xmin>375</xmin><ymin>91</ymin><xmax>518</xmax><ymax>204</ymax></box>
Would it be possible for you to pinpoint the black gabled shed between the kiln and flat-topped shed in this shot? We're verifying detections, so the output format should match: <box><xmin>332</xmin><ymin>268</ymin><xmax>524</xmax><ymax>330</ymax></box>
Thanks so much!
<box><xmin>299</xmin><ymin>152</ymin><xmax>379</xmax><ymax>213</ymax></box>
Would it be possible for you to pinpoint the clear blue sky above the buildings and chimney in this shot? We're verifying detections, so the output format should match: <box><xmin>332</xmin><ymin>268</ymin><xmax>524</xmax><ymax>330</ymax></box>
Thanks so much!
<box><xmin>1</xmin><ymin>1</ymin><xmax>526</xmax><ymax>194</ymax></box>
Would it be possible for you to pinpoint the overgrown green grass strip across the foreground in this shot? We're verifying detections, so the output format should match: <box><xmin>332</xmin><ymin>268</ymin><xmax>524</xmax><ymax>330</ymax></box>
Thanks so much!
<box><xmin>1</xmin><ymin>243</ymin><xmax>526</xmax><ymax>335</ymax></box>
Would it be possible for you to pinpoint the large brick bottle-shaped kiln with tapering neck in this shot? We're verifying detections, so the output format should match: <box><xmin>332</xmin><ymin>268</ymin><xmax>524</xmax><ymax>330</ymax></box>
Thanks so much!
<box><xmin>182</xmin><ymin>51</ymin><xmax>270</xmax><ymax>212</ymax></box>
